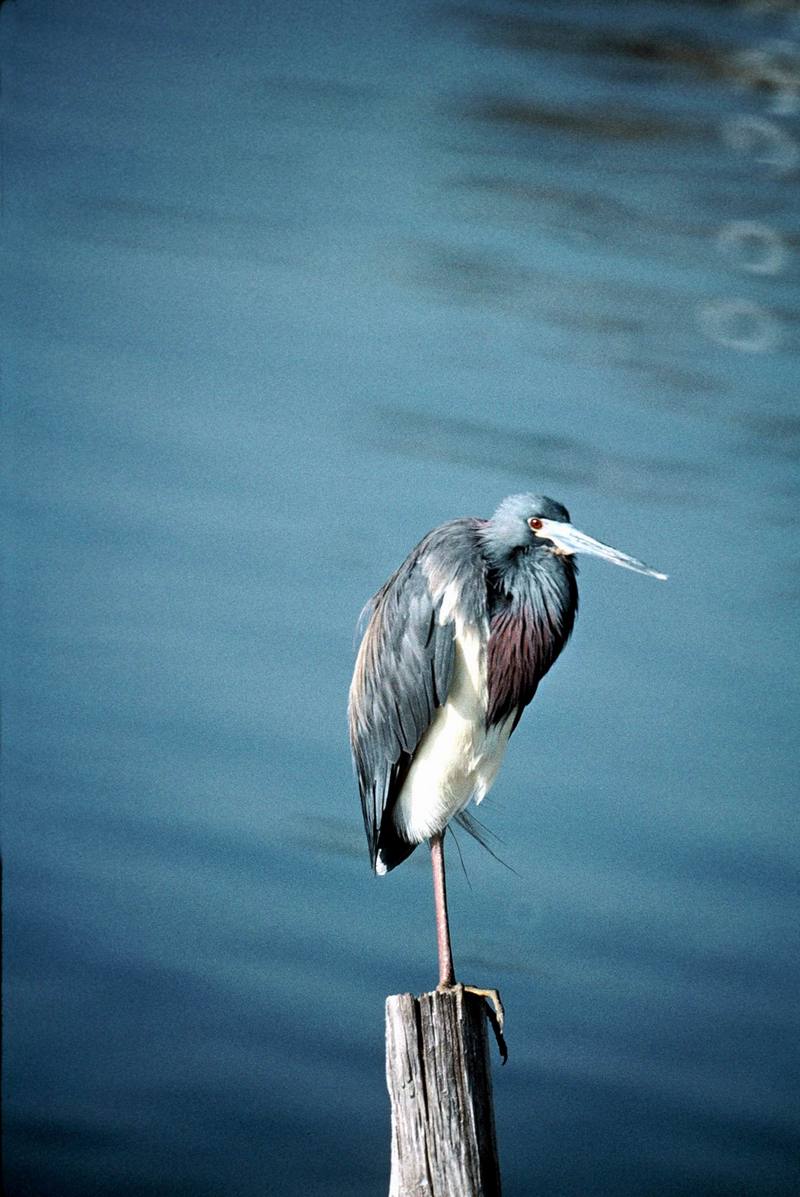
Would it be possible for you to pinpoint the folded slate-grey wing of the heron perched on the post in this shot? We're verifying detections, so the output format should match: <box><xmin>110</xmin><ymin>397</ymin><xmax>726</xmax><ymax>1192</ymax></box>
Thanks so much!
<box><xmin>349</xmin><ymin>519</ymin><xmax>486</xmax><ymax>871</ymax></box>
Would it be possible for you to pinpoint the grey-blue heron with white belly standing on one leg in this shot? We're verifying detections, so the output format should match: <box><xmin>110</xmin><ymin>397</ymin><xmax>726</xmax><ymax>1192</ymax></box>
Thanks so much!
<box><xmin>349</xmin><ymin>494</ymin><xmax>667</xmax><ymax>1005</ymax></box>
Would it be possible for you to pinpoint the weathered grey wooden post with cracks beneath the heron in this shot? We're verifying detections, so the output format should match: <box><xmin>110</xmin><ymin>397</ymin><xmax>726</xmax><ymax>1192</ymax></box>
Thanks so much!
<box><xmin>386</xmin><ymin>985</ymin><xmax>501</xmax><ymax>1197</ymax></box>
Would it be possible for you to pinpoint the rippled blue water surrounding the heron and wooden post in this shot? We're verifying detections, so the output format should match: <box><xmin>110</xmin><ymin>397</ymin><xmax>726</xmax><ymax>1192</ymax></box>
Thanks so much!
<box><xmin>6</xmin><ymin>0</ymin><xmax>800</xmax><ymax>1197</ymax></box>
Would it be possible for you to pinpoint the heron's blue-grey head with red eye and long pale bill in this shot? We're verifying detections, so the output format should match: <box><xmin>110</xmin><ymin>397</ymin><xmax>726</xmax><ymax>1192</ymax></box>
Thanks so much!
<box><xmin>484</xmin><ymin>494</ymin><xmax>666</xmax><ymax>581</ymax></box>
